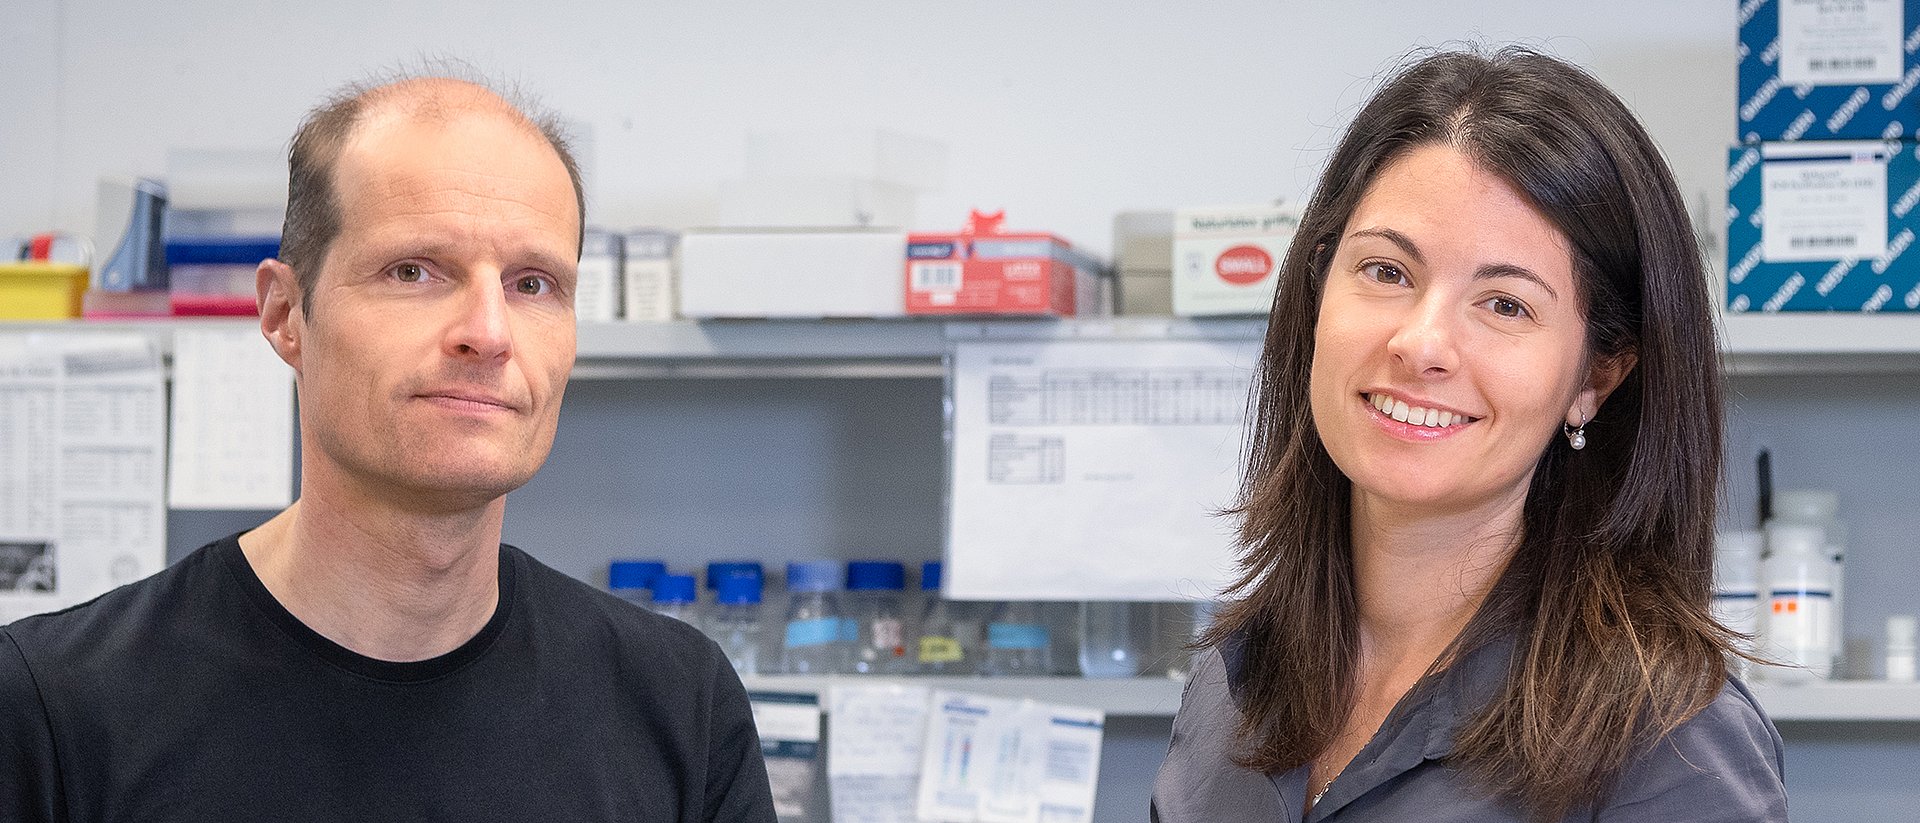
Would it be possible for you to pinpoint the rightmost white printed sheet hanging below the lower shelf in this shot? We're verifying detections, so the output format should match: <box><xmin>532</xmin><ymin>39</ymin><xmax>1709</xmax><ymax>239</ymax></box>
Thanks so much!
<box><xmin>920</xmin><ymin>691</ymin><xmax>1106</xmax><ymax>823</ymax></box>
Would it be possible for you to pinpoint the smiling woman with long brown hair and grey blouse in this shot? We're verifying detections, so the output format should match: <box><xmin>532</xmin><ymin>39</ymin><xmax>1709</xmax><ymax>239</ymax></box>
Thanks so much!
<box><xmin>1154</xmin><ymin>48</ymin><xmax>1786</xmax><ymax>823</ymax></box>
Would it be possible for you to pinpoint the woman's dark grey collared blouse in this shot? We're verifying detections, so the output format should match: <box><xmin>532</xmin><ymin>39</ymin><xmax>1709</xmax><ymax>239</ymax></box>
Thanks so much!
<box><xmin>1152</xmin><ymin>643</ymin><xmax>1788</xmax><ymax>823</ymax></box>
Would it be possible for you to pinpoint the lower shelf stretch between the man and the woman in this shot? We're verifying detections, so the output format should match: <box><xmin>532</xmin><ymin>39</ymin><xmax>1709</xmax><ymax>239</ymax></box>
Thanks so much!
<box><xmin>743</xmin><ymin>675</ymin><xmax>1187</xmax><ymax>717</ymax></box>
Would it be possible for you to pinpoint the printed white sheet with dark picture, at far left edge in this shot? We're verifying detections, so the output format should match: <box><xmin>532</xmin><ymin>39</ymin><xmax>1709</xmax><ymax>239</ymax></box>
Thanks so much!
<box><xmin>0</xmin><ymin>334</ymin><xmax>167</xmax><ymax>623</ymax></box>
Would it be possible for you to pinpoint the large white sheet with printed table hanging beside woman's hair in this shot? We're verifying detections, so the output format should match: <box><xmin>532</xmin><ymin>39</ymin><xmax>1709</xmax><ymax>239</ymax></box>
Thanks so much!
<box><xmin>947</xmin><ymin>336</ymin><xmax>1260</xmax><ymax>600</ymax></box>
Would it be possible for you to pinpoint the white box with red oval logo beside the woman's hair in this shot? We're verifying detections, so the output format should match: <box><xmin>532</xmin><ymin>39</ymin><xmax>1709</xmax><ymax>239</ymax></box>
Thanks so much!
<box><xmin>1173</xmin><ymin>205</ymin><xmax>1300</xmax><ymax>317</ymax></box>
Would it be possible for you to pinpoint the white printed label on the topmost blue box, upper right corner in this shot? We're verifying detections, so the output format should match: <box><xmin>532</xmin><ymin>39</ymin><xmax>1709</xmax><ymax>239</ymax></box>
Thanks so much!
<box><xmin>1780</xmin><ymin>0</ymin><xmax>1905</xmax><ymax>86</ymax></box>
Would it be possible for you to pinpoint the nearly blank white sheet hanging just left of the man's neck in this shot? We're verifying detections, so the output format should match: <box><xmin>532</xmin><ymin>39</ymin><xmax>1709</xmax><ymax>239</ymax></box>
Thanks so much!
<box><xmin>167</xmin><ymin>326</ymin><xmax>294</xmax><ymax>508</ymax></box>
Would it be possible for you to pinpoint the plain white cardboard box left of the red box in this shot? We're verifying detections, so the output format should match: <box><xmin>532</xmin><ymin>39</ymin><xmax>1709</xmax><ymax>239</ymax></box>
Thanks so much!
<box><xmin>680</xmin><ymin>228</ymin><xmax>906</xmax><ymax>318</ymax></box>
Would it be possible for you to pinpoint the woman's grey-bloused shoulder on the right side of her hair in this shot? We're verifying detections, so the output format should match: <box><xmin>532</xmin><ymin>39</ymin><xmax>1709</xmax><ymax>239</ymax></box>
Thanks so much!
<box><xmin>1597</xmin><ymin>677</ymin><xmax>1788</xmax><ymax>821</ymax></box>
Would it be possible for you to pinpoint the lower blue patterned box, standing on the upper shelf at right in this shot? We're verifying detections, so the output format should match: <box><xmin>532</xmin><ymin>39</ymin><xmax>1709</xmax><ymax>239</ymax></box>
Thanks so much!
<box><xmin>1726</xmin><ymin>140</ymin><xmax>1920</xmax><ymax>313</ymax></box>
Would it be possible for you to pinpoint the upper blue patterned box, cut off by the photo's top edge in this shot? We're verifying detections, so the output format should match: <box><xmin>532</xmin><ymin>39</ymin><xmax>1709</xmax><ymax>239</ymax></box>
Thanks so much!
<box><xmin>1738</xmin><ymin>0</ymin><xmax>1920</xmax><ymax>142</ymax></box>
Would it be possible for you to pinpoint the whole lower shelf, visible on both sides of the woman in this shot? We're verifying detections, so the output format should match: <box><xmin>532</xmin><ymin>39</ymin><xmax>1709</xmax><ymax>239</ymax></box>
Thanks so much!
<box><xmin>743</xmin><ymin>675</ymin><xmax>1920</xmax><ymax>723</ymax></box>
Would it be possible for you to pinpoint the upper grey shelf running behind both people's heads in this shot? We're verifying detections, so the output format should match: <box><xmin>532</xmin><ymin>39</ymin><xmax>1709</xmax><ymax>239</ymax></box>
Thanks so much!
<box><xmin>0</xmin><ymin>313</ymin><xmax>1920</xmax><ymax>380</ymax></box>
